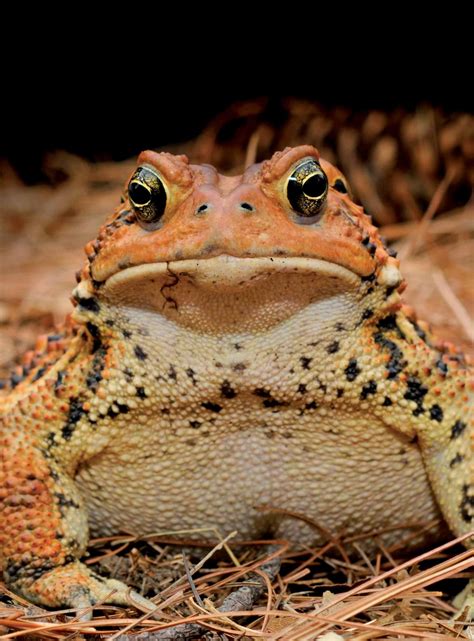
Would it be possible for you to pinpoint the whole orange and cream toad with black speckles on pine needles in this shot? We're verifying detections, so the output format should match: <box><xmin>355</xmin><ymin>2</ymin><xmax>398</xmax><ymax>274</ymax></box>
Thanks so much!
<box><xmin>0</xmin><ymin>146</ymin><xmax>474</xmax><ymax>607</ymax></box>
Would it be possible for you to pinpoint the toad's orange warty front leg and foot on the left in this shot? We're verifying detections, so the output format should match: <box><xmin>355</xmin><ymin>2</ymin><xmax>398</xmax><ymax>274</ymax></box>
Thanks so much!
<box><xmin>0</xmin><ymin>433</ymin><xmax>154</xmax><ymax>609</ymax></box>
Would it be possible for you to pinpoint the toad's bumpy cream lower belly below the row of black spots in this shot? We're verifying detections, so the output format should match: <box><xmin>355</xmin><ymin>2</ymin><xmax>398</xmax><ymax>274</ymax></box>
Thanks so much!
<box><xmin>76</xmin><ymin>409</ymin><xmax>439</xmax><ymax>542</ymax></box>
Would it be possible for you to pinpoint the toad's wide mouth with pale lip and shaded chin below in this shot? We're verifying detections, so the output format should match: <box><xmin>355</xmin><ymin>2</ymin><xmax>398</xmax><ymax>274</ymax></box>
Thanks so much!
<box><xmin>100</xmin><ymin>255</ymin><xmax>361</xmax><ymax>333</ymax></box>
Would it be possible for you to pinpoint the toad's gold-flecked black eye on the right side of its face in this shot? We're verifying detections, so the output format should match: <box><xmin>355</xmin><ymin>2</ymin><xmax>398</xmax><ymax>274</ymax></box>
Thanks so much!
<box><xmin>286</xmin><ymin>158</ymin><xmax>328</xmax><ymax>218</ymax></box>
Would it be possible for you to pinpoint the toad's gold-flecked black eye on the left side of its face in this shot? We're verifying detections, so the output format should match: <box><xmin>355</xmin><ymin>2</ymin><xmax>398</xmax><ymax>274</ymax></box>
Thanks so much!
<box><xmin>128</xmin><ymin>166</ymin><xmax>166</xmax><ymax>223</ymax></box>
